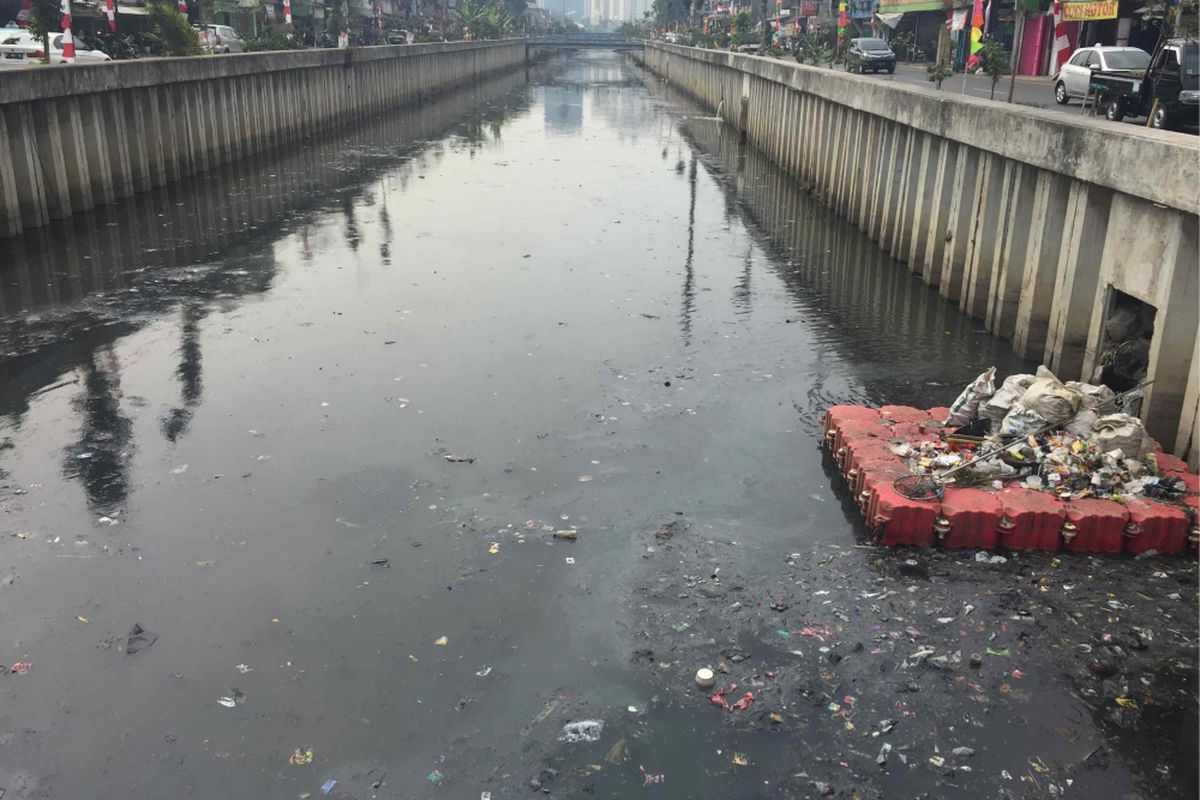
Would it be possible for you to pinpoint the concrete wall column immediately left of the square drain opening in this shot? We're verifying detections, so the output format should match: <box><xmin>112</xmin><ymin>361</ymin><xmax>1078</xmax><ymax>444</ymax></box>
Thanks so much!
<box><xmin>1043</xmin><ymin>180</ymin><xmax>1112</xmax><ymax>380</ymax></box>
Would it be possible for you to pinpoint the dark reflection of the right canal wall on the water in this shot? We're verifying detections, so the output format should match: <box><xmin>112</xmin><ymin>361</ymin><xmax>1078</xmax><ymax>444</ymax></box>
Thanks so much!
<box><xmin>649</xmin><ymin>89</ymin><xmax>1030</xmax><ymax>408</ymax></box>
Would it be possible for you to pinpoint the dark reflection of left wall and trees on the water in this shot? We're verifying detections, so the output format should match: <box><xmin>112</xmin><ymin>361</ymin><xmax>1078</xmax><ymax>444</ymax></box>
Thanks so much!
<box><xmin>0</xmin><ymin>64</ymin><xmax>544</xmax><ymax>515</ymax></box>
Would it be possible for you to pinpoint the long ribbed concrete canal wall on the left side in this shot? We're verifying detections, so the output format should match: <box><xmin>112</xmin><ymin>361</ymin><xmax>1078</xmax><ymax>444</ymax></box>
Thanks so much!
<box><xmin>0</xmin><ymin>40</ymin><xmax>526</xmax><ymax>237</ymax></box>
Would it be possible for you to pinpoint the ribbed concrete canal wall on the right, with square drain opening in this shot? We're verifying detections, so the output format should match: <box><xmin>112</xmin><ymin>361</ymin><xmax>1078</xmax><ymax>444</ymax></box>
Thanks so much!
<box><xmin>642</xmin><ymin>43</ymin><xmax>1200</xmax><ymax>467</ymax></box>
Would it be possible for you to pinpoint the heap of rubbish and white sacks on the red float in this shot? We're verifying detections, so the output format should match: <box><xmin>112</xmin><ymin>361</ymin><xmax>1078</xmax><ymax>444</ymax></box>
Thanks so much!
<box><xmin>893</xmin><ymin>367</ymin><xmax>1187</xmax><ymax>500</ymax></box>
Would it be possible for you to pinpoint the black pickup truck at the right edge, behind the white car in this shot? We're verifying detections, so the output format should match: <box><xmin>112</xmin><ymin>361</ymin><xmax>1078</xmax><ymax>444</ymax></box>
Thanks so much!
<box><xmin>1090</xmin><ymin>38</ymin><xmax>1200</xmax><ymax>128</ymax></box>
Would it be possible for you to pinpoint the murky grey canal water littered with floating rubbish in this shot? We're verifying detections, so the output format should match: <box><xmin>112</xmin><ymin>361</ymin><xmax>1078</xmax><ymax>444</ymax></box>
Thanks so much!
<box><xmin>0</xmin><ymin>53</ymin><xmax>1196</xmax><ymax>800</ymax></box>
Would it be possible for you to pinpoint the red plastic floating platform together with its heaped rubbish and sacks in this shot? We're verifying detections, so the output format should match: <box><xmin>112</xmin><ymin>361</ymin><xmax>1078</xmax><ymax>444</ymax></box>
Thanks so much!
<box><xmin>823</xmin><ymin>367</ymin><xmax>1200</xmax><ymax>554</ymax></box>
